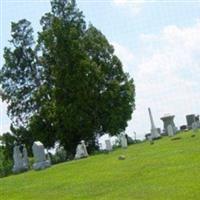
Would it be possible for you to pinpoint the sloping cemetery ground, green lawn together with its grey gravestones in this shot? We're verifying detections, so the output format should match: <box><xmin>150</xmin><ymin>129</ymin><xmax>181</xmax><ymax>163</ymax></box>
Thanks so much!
<box><xmin>0</xmin><ymin>108</ymin><xmax>200</xmax><ymax>200</ymax></box>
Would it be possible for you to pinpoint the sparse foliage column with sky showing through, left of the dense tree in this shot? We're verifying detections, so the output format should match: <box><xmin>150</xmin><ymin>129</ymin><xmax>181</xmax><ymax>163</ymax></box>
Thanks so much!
<box><xmin>0</xmin><ymin>19</ymin><xmax>39</xmax><ymax>126</ymax></box>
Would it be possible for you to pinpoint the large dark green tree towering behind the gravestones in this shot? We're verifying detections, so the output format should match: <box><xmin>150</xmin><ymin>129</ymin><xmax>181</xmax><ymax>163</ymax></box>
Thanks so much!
<box><xmin>1</xmin><ymin>0</ymin><xmax>135</xmax><ymax>154</ymax></box>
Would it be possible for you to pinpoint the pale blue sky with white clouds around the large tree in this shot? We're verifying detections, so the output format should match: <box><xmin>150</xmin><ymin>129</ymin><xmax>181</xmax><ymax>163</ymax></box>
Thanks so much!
<box><xmin>0</xmin><ymin>0</ymin><xmax>200</xmax><ymax>138</ymax></box>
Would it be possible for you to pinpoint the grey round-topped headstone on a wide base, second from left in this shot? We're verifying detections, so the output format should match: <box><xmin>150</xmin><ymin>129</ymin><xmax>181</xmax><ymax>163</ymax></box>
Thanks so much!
<box><xmin>32</xmin><ymin>141</ymin><xmax>51</xmax><ymax>170</ymax></box>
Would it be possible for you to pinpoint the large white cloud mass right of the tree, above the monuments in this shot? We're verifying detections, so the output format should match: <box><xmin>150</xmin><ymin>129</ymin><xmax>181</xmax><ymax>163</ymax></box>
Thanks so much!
<box><xmin>114</xmin><ymin>22</ymin><xmax>200</xmax><ymax>138</ymax></box>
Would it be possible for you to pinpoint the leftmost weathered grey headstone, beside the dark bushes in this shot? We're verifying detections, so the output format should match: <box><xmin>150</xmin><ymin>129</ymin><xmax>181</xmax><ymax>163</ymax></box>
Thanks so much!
<box><xmin>12</xmin><ymin>145</ymin><xmax>28</xmax><ymax>173</ymax></box>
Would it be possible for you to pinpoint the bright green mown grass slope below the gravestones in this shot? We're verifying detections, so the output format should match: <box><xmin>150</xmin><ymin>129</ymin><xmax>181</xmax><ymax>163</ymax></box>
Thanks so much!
<box><xmin>0</xmin><ymin>132</ymin><xmax>200</xmax><ymax>200</ymax></box>
